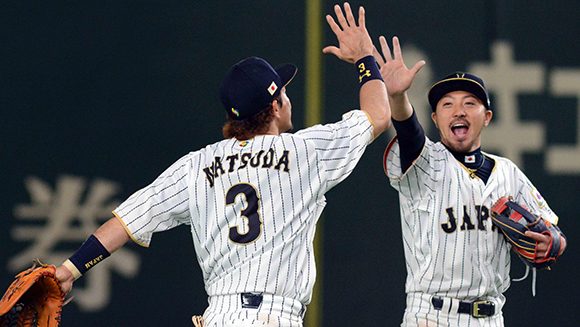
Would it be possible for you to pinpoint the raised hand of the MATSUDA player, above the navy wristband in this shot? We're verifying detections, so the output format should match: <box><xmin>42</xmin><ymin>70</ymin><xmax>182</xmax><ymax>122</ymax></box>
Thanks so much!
<box><xmin>322</xmin><ymin>2</ymin><xmax>374</xmax><ymax>63</ymax></box>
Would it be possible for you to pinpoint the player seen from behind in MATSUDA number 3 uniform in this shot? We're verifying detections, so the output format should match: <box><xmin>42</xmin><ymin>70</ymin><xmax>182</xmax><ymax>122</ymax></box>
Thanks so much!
<box><xmin>57</xmin><ymin>3</ymin><xmax>391</xmax><ymax>327</ymax></box>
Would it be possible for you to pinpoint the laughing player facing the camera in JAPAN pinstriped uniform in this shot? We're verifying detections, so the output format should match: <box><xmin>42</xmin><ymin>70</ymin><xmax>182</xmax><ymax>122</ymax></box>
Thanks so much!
<box><xmin>375</xmin><ymin>37</ymin><xmax>566</xmax><ymax>326</ymax></box>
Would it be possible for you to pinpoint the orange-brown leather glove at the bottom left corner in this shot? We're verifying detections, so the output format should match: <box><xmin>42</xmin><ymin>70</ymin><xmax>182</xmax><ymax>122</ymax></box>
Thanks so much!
<box><xmin>0</xmin><ymin>260</ymin><xmax>65</xmax><ymax>327</ymax></box>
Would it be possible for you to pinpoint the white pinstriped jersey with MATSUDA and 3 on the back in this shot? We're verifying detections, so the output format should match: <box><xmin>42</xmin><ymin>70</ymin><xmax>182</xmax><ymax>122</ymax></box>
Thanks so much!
<box><xmin>113</xmin><ymin>110</ymin><xmax>372</xmax><ymax>304</ymax></box>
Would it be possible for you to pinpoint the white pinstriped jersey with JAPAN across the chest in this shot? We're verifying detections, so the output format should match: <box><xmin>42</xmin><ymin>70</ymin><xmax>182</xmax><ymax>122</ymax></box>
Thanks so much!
<box><xmin>384</xmin><ymin>138</ymin><xmax>558</xmax><ymax>326</ymax></box>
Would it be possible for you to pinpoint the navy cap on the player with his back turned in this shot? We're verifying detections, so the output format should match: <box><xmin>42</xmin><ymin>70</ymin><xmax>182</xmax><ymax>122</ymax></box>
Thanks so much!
<box><xmin>220</xmin><ymin>57</ymin><xmax>298</xmax><ymax>120</ymax></box>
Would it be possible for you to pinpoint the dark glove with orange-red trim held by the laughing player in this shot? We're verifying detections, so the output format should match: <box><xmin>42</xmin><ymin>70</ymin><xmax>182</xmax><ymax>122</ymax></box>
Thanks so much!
<box><xmin>491</xmin><ymin>197</ymin><xmax>564</xmax><ymax>269</ymax></box>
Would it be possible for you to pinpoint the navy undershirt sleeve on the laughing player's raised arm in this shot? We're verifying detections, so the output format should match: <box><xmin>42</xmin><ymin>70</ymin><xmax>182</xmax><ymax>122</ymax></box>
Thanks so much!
<box><xmin>392</xmin><ymin>110</ymin><xmax>425</xmax><ymax>173</ymax></box>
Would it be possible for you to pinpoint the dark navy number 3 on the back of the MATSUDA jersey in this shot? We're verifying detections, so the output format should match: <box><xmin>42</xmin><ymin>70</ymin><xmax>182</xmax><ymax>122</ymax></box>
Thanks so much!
<box><xmin>226</xmin><ymin>184</ymin><xmax>262</xmax><ymax>244</ymax></box>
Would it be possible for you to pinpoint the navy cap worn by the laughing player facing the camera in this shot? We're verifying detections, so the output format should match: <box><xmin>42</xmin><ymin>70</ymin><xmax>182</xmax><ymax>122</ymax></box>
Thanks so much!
<box><xmin>428</xmin><ymin>72</ymin><xmax>491</xmax><ymax>111</ymax></box>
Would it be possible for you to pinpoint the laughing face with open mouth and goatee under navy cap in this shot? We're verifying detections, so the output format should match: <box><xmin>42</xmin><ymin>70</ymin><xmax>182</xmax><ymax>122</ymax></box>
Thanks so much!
<box><xmin>431</xmin><ymin>91</ymin><xmax>493</xmax><ymax>153</ymax></box>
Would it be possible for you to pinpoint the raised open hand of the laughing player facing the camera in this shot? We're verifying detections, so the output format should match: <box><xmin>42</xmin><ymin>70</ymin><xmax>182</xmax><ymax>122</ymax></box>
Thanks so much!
<box><xmin>373</xmin><ymin>36</ymin><xmax>425</xmax><ymax>97</ymax></box>
